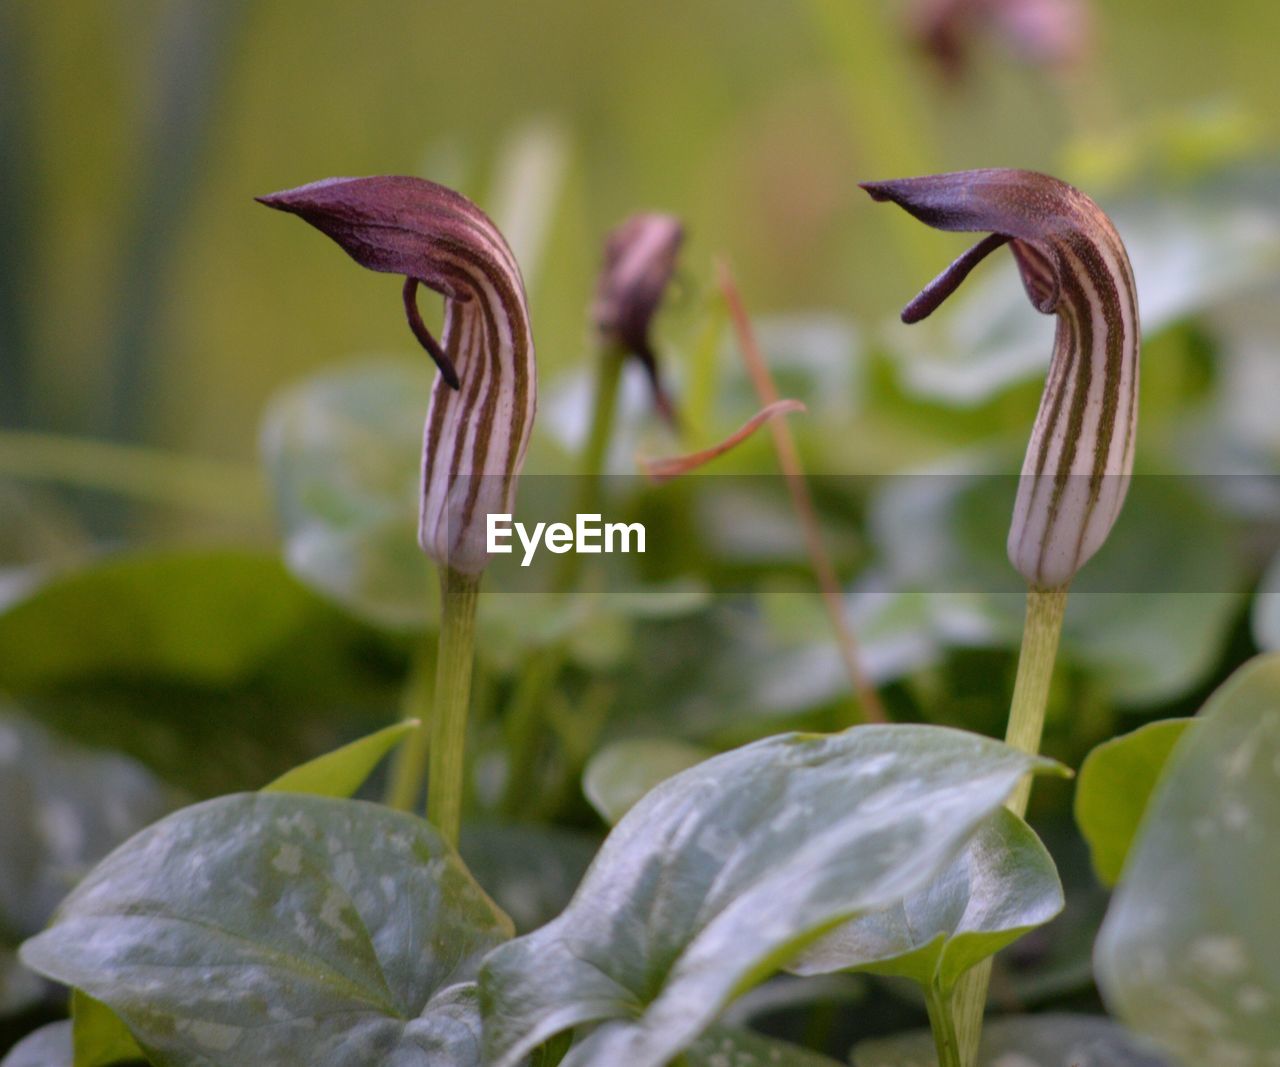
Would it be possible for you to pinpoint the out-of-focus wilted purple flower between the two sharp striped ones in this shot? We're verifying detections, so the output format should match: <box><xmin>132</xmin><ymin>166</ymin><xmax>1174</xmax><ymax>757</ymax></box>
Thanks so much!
<box><xmin>594</xmin><ymin>214</ymin><xmax>685</xmax><ymax>422</ymax></box>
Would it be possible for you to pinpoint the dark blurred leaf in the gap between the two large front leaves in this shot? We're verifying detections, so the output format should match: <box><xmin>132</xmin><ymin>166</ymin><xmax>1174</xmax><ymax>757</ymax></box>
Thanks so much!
<box><xmin>458</xmin><ymin>820</ymin><xmax>600</xmax><ymax>933</ymax></box>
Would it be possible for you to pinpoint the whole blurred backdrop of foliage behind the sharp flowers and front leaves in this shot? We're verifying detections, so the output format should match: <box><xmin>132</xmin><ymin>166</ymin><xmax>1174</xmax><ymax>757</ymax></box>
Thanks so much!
<box><xmin>0</xmin><ymin>0</ymin><xmax>1280</xmax><ymax>1049</ymax></box>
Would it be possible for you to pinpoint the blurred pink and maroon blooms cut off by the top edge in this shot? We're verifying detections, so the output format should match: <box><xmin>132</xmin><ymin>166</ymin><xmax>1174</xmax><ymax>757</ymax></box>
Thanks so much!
<box><xmin>910</xmin><ymin>0</ymin><xmax>1092</xmax><ymax>78</ymax></box>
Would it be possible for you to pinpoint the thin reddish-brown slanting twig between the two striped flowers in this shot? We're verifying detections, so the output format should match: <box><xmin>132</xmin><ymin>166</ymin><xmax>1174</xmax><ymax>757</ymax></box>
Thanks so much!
<box><xmin>717</xmin><ymin>260</ymin><xmax>888</xmax><ymax>723</ymax></box>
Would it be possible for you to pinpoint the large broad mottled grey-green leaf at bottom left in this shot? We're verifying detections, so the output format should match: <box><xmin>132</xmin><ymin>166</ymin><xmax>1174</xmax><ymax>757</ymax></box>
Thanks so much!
<box><xmin>23</xmin><ymin>793</ymin><xmax>511</xmax><ymax>1067</ymax></box>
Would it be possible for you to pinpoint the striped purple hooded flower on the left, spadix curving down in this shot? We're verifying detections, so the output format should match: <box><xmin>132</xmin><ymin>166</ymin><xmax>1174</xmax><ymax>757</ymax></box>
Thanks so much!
<box><xmin>259</xmin><ymin>177</ymin><xmax>536</xmax><ymax>574</ymax></box>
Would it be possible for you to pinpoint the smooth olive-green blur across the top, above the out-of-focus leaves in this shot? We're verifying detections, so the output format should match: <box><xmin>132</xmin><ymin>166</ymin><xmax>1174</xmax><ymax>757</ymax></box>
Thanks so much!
<box><xmin>0</xmin><ymin>0</ymin><xmax>1280</xmax><ymax>468</ymax></box>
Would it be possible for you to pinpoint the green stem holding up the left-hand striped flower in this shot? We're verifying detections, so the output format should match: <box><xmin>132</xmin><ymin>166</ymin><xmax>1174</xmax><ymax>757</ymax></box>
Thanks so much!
<box><xmin>426</xmin><ymin>567</ymin><xmax>480</xmax><ymax>846</ymax></box>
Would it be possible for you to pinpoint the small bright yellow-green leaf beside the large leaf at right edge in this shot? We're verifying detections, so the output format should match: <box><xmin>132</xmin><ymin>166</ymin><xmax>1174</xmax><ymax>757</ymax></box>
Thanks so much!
<box><xmin>1075</xmin><ymin>719</ymin><xmax>1192</xmax><ymax>885</ymax></box>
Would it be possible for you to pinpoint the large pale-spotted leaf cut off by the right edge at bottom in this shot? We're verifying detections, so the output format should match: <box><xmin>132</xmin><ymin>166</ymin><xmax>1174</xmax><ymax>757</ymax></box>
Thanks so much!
<box><xmin>1094</xmin><ymin>654</ymin><xmax>1280</xmax><ymax>1067</ymax></box>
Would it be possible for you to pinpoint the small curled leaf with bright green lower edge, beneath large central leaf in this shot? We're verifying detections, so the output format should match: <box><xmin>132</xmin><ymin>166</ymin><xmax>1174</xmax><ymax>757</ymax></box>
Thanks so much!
<box><xmin>788</xmin><ymin>809</ymin><xmax>1062</xmax><ymax>995</ymax></box>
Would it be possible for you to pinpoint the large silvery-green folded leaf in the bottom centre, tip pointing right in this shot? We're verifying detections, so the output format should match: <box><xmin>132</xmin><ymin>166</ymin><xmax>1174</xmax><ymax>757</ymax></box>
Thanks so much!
<box><xmin>481</xmin><ymin>725</ymin><xmax>1051</xmax><ymax>1067</ymax></box>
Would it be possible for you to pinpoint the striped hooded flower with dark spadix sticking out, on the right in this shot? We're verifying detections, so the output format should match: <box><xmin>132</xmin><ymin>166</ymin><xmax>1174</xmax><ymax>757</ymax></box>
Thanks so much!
<box><xmin>863</xmin><ymin>170</ymin><xmax>1139</xmax><ymax>589</ymax></box>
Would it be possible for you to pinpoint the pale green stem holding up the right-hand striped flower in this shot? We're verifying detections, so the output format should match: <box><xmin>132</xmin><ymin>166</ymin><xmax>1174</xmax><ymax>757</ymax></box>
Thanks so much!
<box><xmin>952</xmin><ymin>586</ymin><xmax>1066</xmax><ymax>1067</ymax></box>
